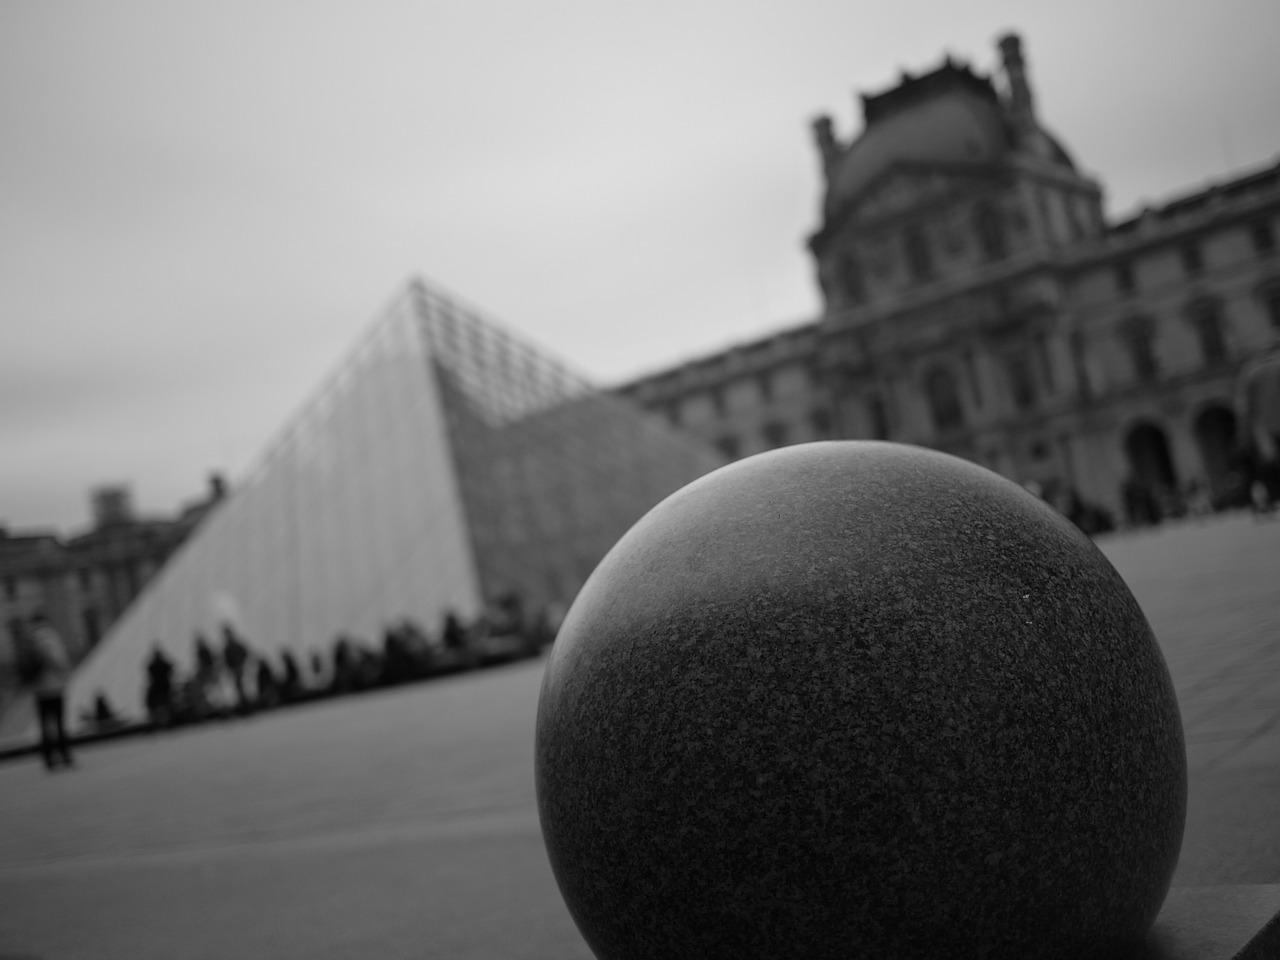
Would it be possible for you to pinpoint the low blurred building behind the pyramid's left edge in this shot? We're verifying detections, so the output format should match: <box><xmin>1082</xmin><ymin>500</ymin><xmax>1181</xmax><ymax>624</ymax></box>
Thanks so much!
<box><xmin>0</xmin><ymin>474</ymin><xmax>227</xmax><ymax>687</ymax></box>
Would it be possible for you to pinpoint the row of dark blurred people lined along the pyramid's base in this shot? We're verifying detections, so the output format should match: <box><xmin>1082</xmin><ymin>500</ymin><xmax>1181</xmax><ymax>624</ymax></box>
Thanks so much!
<box><xmin>83</xmin><ymin>598</ymin><xmax>557</xmax><ymax>731</ymax></box>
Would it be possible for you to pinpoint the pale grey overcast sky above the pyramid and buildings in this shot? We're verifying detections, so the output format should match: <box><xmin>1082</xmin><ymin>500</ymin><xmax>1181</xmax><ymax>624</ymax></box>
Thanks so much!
<box><xmin>0</xmin><ymin>0</ymin><xmax>1280</xmax><ymax>531</ymax></box>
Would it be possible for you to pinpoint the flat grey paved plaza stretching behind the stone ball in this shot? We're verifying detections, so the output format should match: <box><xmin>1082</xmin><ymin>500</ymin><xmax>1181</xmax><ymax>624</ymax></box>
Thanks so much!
<box><xmin>0</xmin><ymin>516</ymin><xmax>1280</xmax><ymax>960</ymax></box>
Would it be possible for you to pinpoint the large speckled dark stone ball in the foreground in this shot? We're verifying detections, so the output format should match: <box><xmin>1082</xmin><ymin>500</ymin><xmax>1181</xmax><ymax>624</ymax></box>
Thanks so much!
<box><xmin>536</xmin><ymin>442</ymin><xmax>1187</xmax><ymax>960</ymax></box>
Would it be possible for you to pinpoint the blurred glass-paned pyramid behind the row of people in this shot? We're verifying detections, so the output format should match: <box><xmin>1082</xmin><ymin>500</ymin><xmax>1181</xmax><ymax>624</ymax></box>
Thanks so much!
<box><xmin>68</xmin><ymin>283</ymin><xmax>723</xmax><ymax>721</ymax></box>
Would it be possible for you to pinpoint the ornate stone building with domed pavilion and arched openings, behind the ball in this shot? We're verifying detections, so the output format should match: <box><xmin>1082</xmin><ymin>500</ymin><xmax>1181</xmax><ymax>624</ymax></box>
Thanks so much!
<box><xmin>620</xmin><ymin>36</ymin><xmax>1280</xmax><ymax>515</ymax></box>
